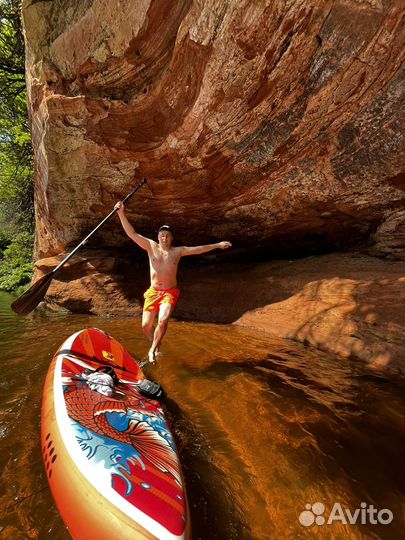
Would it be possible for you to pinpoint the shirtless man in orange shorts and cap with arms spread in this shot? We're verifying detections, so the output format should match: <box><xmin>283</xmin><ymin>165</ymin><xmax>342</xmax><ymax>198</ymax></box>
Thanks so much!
<box><xmin>115</xmin><ymin>202</ymin><xmax>232</xmax><ymax>362</ymax></box>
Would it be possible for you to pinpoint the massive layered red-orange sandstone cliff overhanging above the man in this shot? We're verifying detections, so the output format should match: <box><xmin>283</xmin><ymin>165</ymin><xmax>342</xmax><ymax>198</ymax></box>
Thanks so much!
<box><xmin>23</xmin><ymin>0</ymin><xmax>405</xmax><ymax>372</ymax></box>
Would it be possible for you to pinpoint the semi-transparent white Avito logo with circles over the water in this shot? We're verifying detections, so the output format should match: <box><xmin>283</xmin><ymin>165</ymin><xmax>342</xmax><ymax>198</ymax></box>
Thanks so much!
<box><xmin>298</xmin><ymin>502</ymin><xmax>394</xmax><ymax>527</ymax></box>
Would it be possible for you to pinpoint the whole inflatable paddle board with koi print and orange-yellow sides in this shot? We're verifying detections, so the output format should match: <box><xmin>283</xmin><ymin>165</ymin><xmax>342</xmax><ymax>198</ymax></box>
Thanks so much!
<box><xmin>41</xmin><ymin>329</ymin><xmax>191</xmax><ymax>540</ymax></box>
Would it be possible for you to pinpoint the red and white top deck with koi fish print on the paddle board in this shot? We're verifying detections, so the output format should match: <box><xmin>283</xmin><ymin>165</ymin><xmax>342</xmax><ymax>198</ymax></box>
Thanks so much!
<box><xmin>49</xmin><ymin>329</ymin><xmax>187</xmax><ymax>538</ymax></box>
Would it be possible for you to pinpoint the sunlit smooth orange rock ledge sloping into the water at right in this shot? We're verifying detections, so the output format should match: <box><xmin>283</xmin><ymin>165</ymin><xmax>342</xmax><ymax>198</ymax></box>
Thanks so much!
<box><xmin>262</xmin><ymin>278</ymin><xmax>405</xmax><ymax>375</ymax></box>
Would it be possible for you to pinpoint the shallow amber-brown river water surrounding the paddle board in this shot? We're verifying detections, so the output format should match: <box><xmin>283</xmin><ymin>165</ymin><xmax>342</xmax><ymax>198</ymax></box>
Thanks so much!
<box><xmin>0</xmin><ymin>294</ymin><xmax>405</xmax><ymax>540</ymax></box>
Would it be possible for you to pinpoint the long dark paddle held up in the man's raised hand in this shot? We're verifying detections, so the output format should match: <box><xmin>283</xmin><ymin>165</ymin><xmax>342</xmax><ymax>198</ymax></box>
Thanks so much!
<box><xmin>11</xmin><ymin>178</ymin><xmax>146</xmax><ymax>315</ymax></box>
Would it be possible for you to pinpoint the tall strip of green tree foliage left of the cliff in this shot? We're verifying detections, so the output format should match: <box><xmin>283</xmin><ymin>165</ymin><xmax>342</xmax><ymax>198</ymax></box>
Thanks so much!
<box><xmin>0</xmin><ymin>0</ymin><xmax>34</xmax><ymax>290</ymax></box>
